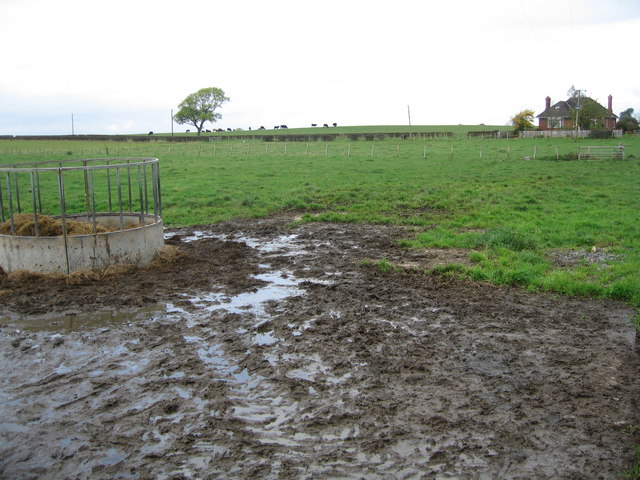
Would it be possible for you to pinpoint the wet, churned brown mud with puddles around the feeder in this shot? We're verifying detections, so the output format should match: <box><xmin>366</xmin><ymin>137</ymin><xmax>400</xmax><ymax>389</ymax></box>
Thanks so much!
<box><xmin>0</xmin><ymin>218</ymin><xmax>640</xmax><ymax>479</ymax></box>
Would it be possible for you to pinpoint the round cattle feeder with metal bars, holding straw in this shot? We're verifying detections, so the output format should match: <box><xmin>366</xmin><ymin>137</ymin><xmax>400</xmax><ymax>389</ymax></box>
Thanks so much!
<box><xmin>0</xmin><ymin>158</ymin><xmax>164</xmax><ymax>273</ymax></box>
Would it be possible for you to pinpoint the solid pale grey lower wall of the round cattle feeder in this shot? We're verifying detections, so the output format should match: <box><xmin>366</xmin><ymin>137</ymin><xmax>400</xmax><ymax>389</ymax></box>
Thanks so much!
<box><xmin>0</xmin><ymin>213</ymin><xmax>164</xmax><ymax>273</ymax></box>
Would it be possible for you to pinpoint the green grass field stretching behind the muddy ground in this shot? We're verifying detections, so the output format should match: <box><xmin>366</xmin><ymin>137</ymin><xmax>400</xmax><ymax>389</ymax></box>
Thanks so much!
<box><xmin>0</xmin><ymin>126</ymin><xmax>640</xmax><ymax>307</ymax></box>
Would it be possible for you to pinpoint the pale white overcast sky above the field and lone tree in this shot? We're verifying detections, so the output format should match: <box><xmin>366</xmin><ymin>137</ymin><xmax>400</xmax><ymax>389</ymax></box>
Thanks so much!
<box><xmin>0</xmin><ymin>0</ymin><xmax>640</xmax><ymax>135</ymax></box>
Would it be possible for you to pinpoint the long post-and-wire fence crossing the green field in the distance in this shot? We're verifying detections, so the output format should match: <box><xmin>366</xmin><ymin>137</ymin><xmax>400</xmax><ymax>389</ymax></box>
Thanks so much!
<box><xmin>0</xmin><ymin>137</ymin><xmax>640</xmax><ymax>162</ymax></box>
